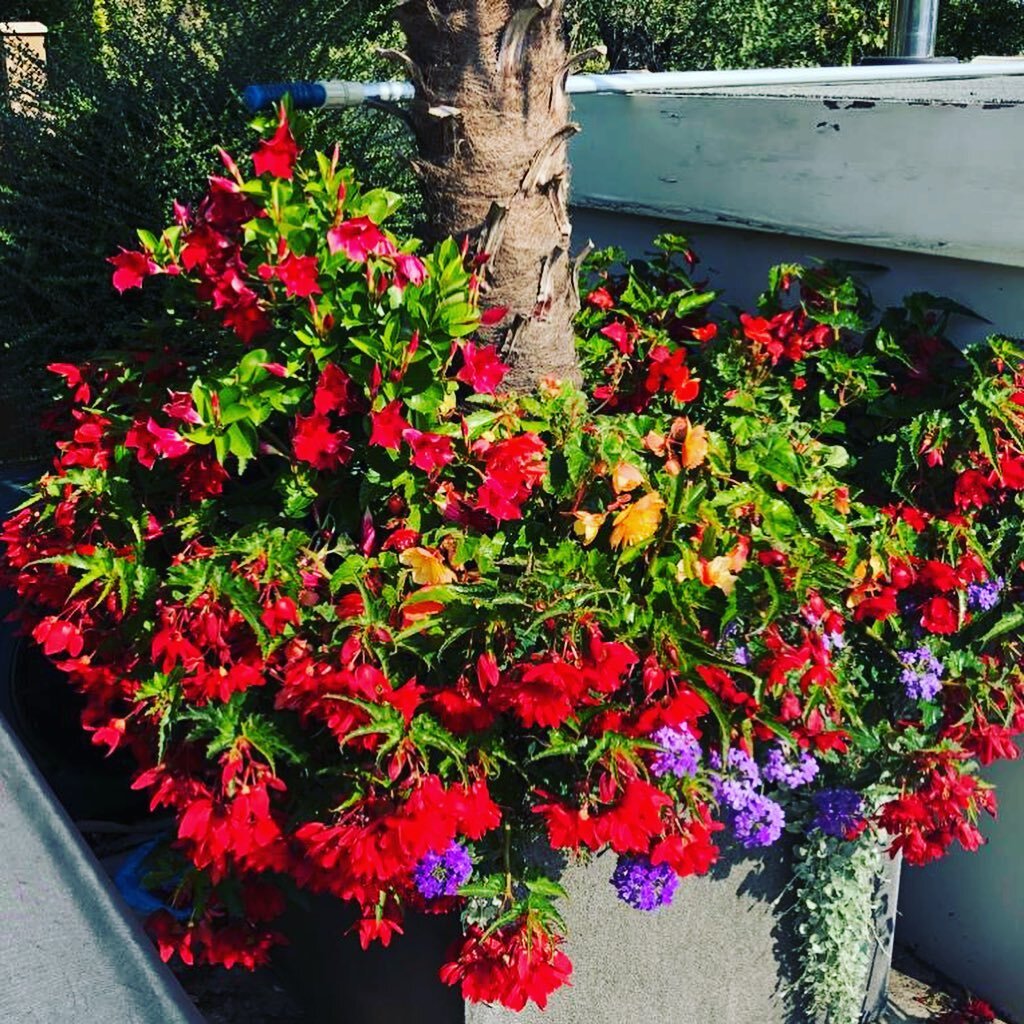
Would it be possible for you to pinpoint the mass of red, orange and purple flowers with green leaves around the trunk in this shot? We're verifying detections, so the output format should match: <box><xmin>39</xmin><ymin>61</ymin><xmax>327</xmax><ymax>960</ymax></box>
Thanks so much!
<box><xmin>3</xmin><ymin>108</ymin><xmax>1024</xmax><ymax>1022</ymax></box>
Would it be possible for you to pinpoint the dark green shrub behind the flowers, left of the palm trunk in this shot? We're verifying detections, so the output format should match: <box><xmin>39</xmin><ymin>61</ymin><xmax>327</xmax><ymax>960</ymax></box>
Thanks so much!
<box><xmin>0</xmin><ymin>0</ymin><xmax>413</xmax><ymax>459</ymax></box>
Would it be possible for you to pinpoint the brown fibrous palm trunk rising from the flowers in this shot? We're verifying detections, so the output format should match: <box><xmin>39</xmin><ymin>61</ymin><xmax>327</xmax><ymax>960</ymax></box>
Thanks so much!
<box><xmin>394</xmin><ymin>0</ymin><xmax>580</xmax><ymax>389</ymax></box>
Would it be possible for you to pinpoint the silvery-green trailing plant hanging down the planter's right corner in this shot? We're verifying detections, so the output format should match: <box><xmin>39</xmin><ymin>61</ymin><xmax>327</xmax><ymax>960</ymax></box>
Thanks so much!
<box><xmin>795</xmin><ymin>830</ymin><xmax>889</xmax><ymax>1024</ymax></box>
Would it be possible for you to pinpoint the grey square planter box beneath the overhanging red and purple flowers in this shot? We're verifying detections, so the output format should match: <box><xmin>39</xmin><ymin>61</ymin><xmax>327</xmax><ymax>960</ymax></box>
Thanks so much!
<box><xmin>282</xmin><ymin>850</ymin><xmax>899</xmax><ymax>1024</ymax></box>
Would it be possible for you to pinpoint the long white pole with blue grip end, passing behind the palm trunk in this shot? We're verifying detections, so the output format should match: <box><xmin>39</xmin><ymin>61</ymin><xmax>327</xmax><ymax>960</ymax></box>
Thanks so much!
<box><xmin>245</xmin><ymin>57</ymin><xmax>1024</xmax><ymax>110</ymax></box>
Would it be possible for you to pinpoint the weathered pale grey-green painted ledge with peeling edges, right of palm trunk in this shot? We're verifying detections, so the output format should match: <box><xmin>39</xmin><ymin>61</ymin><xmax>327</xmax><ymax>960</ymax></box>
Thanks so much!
<box><xmin>570</xmin><ymin>77</ymin><xmax>1024</xmax><ymax>266</ymax></box>
